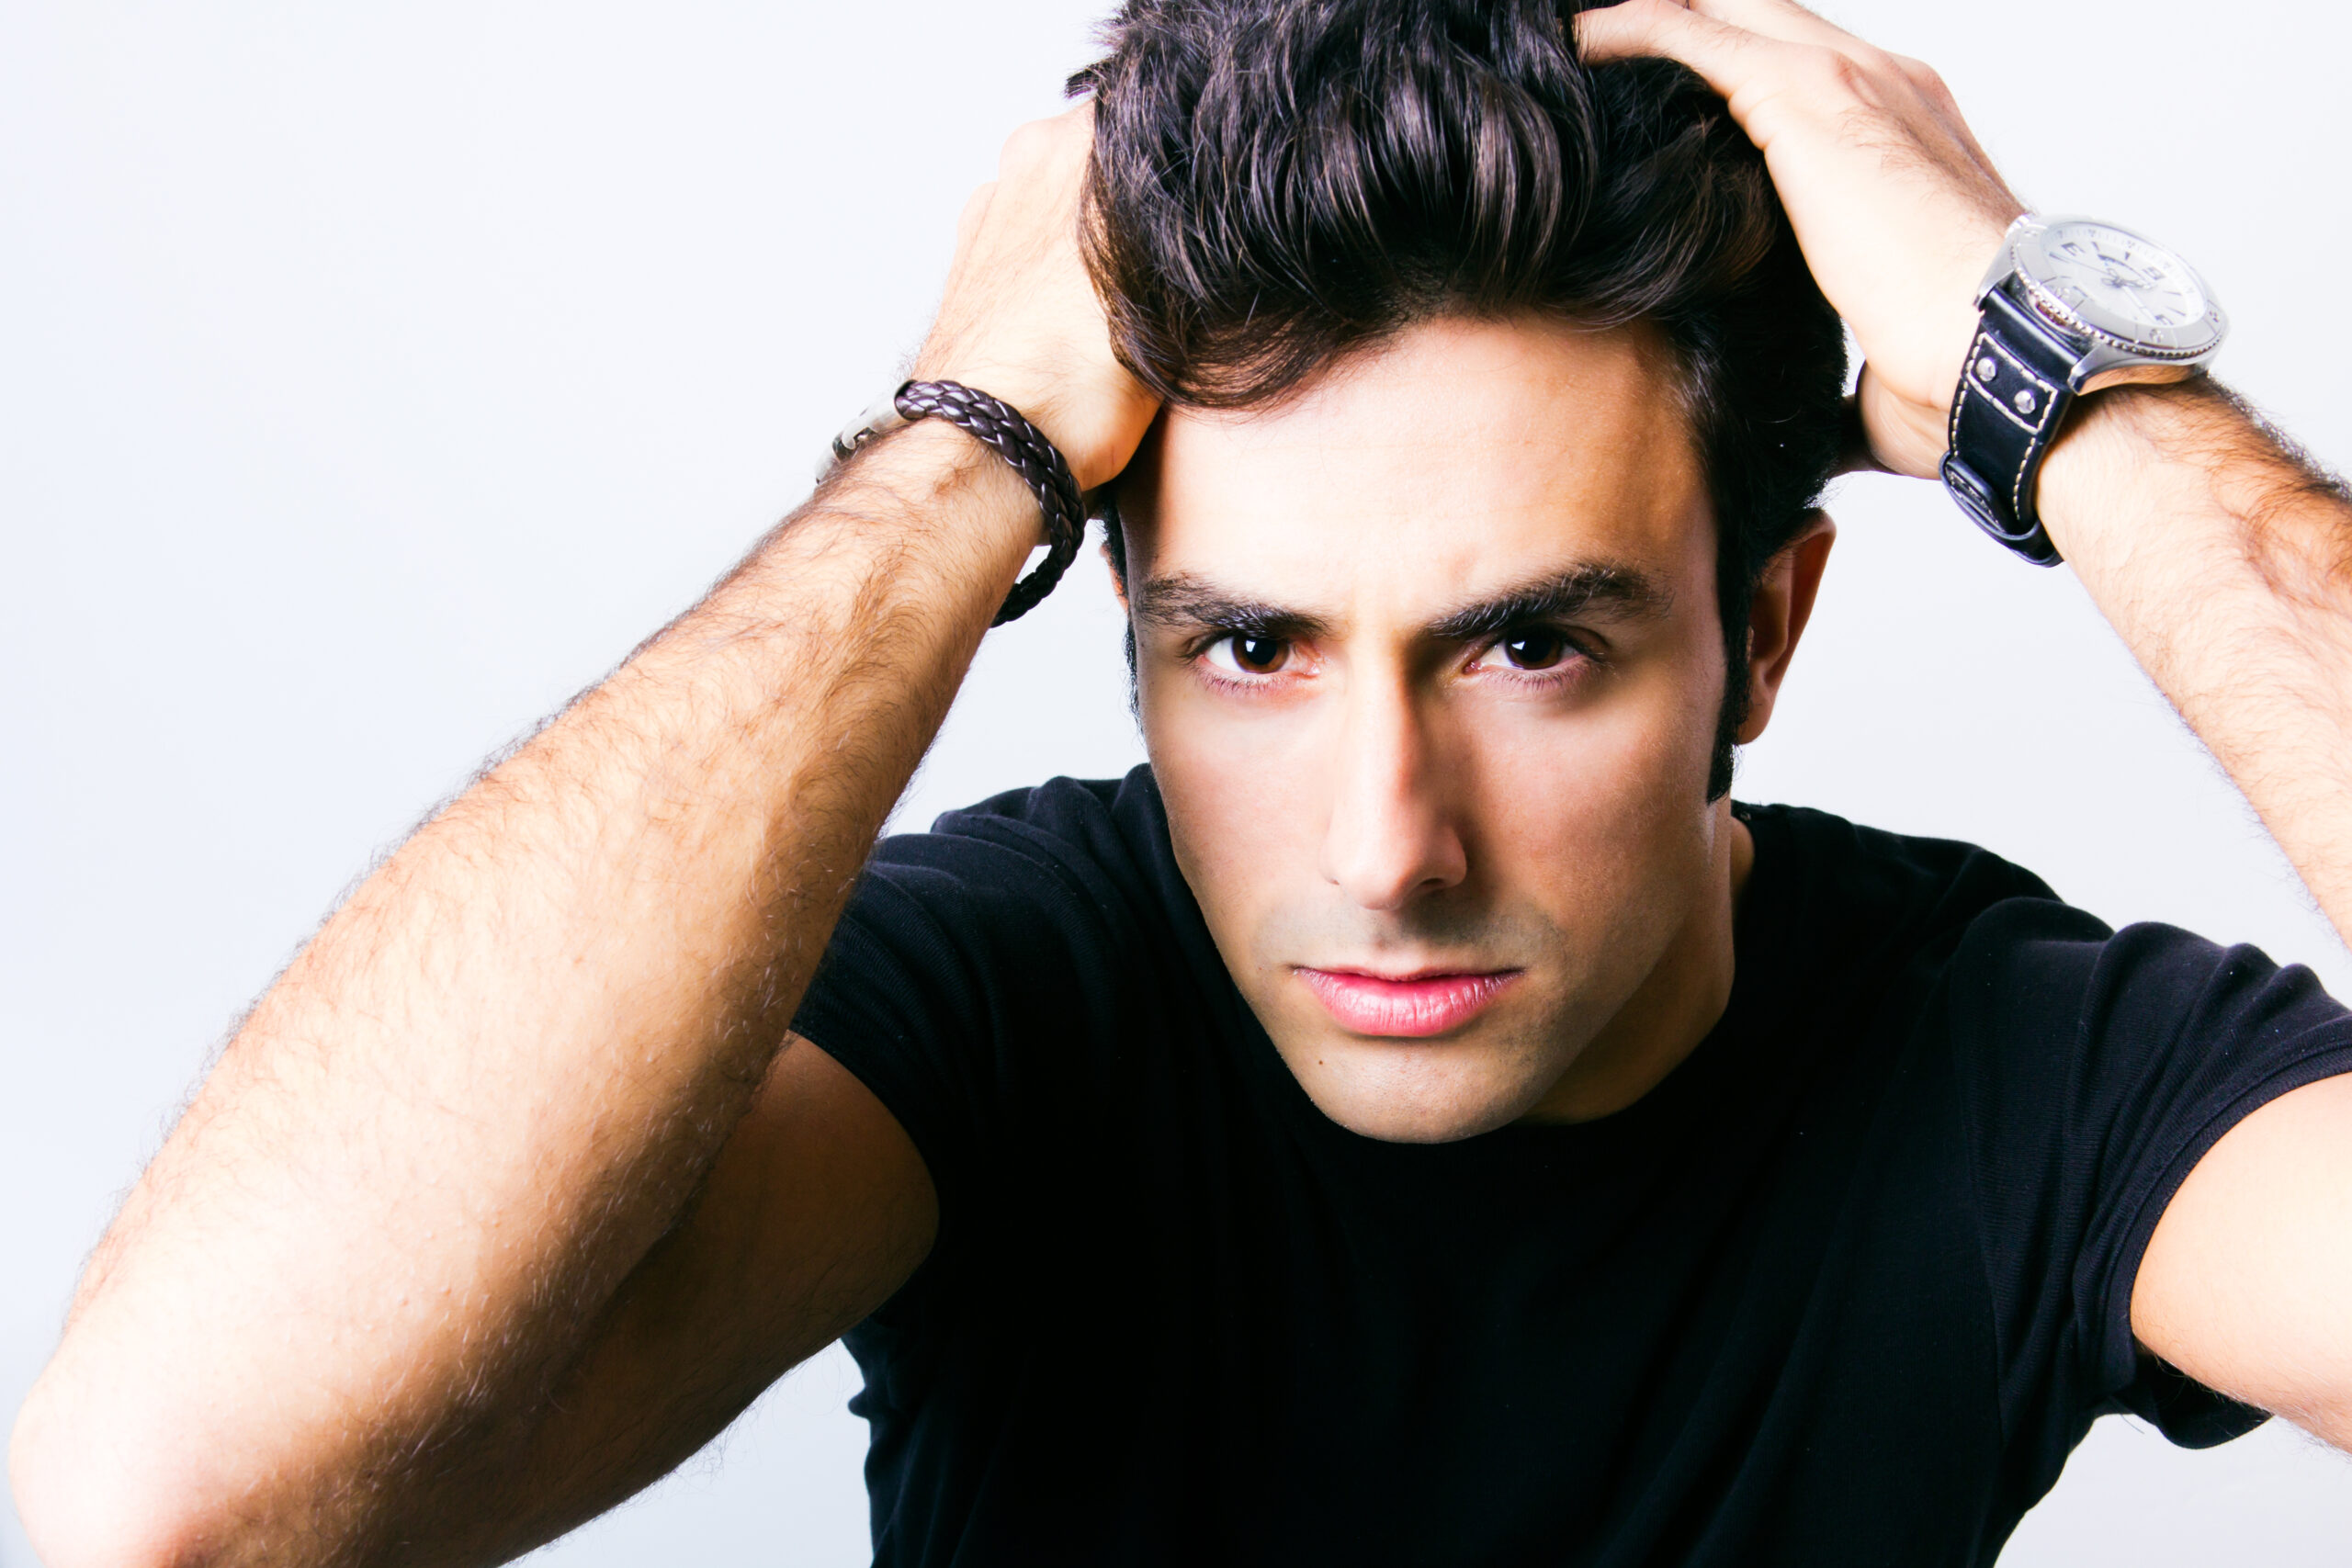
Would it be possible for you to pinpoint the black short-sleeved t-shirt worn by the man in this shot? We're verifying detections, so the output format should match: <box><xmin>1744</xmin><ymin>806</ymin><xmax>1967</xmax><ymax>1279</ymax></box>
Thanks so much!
<box><xmin>795</xmin><ymin>769</ymin><xmax>2352</xmax><ymax>1568</ymax></box>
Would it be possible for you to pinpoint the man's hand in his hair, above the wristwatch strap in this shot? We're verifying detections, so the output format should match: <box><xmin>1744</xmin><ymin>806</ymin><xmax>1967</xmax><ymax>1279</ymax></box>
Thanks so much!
<box><xmin>1576</xmin><ymin>0</ymin><xmax>2023</xmax><ymax>478</ymax></box>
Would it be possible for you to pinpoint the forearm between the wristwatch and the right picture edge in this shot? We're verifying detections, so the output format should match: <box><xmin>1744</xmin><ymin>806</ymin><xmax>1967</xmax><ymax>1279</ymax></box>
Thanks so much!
<box><xmin>2041</xmin><ymin>381</ymin><xmax>2352</xmax><ymax>938</ymax></box>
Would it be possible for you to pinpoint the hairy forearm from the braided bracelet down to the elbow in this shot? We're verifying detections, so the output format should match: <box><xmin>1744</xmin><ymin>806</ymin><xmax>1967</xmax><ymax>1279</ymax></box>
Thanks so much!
<box><xmin>17</xmin><ymin>425</ymin><xmax>1037</xmax><ymax>1561</ymax></box>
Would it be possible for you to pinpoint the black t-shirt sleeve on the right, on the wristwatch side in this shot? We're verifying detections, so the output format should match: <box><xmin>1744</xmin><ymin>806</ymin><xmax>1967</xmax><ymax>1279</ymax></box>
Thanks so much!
<box><xmin>1952</xmin><ymin>898</ymin><xmax>2352</xmax><ymax>1448</ymax></box>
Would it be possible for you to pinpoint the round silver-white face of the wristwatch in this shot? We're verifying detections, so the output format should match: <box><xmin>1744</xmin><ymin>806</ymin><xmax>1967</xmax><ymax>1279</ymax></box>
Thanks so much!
<box><xmin>2011</xmin><ymin>219</ymin><xmax>2222</xmax><ymax>360</ymax></box>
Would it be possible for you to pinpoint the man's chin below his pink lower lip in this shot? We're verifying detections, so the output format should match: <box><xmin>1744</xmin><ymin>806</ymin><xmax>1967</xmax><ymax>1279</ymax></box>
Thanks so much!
<box><xmin>1275</xmin><ymin>1037</ymin><xmax>1566</xmax><ymax>1143</ymax></box>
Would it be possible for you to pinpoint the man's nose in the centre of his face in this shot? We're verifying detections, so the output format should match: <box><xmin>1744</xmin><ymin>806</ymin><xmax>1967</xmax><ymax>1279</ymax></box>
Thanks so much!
<box><xmin>1322</xmin><ymin>680</ymin><xmax>1470</xmax><ymax>909</ymax></box>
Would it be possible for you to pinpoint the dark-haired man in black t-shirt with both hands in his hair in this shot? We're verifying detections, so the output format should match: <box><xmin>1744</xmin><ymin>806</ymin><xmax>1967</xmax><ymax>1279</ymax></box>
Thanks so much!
<box><xmin>12</xmin><ymin>0</ymin><xmax>2352</xmax><ymax>1568</ymax></box>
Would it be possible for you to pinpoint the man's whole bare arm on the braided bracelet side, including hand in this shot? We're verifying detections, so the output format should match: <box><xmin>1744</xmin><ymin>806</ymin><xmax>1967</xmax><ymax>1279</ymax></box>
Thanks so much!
<box><xmin>12</xmin><ymin>110</ymin><xmax>1150</xmax><ymax>1568</ymax></box>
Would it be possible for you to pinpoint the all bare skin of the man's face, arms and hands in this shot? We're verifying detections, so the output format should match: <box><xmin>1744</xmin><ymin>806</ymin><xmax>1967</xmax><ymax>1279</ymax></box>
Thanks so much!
<box><xmin>9</xmin><ymin>0</ymin><xmax>2352</xmax><ymax>1568</ymax></box>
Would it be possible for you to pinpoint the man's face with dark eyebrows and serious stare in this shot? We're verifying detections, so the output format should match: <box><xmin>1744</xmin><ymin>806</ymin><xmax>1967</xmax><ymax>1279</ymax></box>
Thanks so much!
<box><xmin>1120</xmin><ymin>320</ymin><xmax>1787</xmax><ymax>1140</ymax></box>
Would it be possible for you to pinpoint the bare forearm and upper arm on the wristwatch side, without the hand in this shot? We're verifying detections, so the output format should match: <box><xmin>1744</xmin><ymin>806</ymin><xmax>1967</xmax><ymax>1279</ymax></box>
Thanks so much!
<box><xmin>2041</xmin><ymin>386</ymin><xmax>2352</xmax><ymax>1448</ymax></box>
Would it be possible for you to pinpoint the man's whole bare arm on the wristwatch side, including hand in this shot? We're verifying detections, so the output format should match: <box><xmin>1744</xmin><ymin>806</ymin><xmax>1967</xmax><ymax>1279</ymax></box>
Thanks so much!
<box><xmin>1578</xmin><ymin>0</ymin><xmax>2352</xmax><ymax>1448</ymax></box>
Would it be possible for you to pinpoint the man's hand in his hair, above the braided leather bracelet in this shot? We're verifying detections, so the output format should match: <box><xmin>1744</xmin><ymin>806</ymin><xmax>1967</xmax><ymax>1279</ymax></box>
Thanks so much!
<box><xmin>915</xmin><ymin>104</ymin><xmax>1159</xmax><ymax>489</ymax></box>
